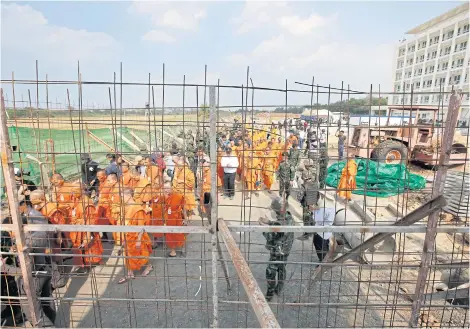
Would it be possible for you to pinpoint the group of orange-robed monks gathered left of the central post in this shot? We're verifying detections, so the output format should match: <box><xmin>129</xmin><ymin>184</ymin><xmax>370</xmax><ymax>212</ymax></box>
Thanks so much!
<box><xmin>31</xmin><ymin>155</ymin><xmax>200</xmax><ymax>283</ymax></box>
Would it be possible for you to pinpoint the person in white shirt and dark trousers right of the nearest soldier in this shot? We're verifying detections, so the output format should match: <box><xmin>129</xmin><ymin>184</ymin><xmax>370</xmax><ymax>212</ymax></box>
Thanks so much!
<box><xmin>311</xmin><ymin>194</ymin><xmax>336</xmax><ymax>261</ymax></box>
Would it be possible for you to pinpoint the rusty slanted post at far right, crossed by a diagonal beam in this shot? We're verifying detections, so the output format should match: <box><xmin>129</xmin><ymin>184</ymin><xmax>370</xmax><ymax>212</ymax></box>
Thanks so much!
<box><xmin>410</xmin><ymin>90</ymin><xmax>462</xmax><ymax>327</ymax></box>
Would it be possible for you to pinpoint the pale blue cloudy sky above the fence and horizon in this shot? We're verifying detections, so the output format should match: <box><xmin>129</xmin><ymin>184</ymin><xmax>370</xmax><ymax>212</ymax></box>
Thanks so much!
<box><xmin>1</xmin><ymin>1</ymin><xmax>461</xmax><ymax>106</ymax></box>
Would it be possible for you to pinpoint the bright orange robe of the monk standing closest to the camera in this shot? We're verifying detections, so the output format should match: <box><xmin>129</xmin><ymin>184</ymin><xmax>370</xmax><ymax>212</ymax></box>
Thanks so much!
<box><xmin>124</xmin><ymin>204</ymin><xmax>152</xmax><ymax>271</ymax></box>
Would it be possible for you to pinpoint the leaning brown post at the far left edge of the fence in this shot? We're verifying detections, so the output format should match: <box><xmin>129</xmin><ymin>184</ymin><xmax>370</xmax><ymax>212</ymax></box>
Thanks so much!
<box><xmin>0</xmin><ymin>88</ymin><xmax>41</xmax><ymax>327</ymax></box>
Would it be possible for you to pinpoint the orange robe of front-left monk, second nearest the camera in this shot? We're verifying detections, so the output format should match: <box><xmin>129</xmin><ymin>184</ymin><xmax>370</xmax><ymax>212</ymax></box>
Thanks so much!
<box><xmin>70</xmin><ymin>197</ymin><xmax>103</xmax><ymax>265</ymax></box>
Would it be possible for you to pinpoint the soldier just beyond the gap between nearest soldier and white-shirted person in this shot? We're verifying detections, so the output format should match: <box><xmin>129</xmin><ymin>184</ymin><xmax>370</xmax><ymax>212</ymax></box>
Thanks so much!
<box><xmin>297</xmin><ymin>159</ymin><xmax>320</xmax><ymax>240</ymax></box>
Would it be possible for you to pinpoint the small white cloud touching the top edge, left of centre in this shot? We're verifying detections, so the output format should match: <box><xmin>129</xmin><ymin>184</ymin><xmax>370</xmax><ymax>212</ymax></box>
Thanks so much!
<box><xmin>129</xmin><ymin>1</ymin><xmax>207</xmax><ymax>31</ymax></box>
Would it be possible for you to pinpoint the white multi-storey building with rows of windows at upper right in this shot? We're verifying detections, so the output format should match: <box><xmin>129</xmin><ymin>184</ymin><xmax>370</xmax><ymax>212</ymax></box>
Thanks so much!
<box><xmin>389</xmin><ymin>3</ymin><xmax>470</xmax><ymax>124</ymax></box>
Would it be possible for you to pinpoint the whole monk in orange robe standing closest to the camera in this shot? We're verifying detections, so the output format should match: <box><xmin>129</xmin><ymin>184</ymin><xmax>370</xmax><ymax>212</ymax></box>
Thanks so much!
<box><xmin>118</xmin><ymin>187</ymin><xmax>153</xmax><ymax>284</ymax></box>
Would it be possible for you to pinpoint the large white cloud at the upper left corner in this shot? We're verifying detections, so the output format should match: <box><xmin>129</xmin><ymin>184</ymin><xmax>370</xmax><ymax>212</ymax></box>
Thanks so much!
<box><xmin>1</xmin><ymin>3</ymin><xmax>119</xmax><ymax>64</ymax></box>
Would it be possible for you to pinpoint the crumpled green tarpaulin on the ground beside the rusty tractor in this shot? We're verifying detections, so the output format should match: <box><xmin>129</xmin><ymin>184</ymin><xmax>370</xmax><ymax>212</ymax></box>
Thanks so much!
<box><xmin>325</xmin><ymin>159</ymin><xmax>426</xmax><ymax>197</ymax></box>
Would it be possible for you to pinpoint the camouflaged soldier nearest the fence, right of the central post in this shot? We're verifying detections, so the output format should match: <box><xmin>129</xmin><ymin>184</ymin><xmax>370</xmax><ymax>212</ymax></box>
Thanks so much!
<box><xmin>260</xmin><ymin>198</ymin><xmax>294</xmax><ymax>302</ymax></box>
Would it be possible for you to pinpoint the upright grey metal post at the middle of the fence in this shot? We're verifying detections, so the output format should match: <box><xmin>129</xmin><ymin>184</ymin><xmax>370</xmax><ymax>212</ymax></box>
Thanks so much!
<box><xmin>209</xmin><ymin>86</ymin><xmax>219</xmax><ymax>328</ymax></box>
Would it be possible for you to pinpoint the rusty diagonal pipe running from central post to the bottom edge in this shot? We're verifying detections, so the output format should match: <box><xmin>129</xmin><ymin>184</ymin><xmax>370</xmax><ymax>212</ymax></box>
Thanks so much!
<box><xmin>217</xmin><ymin>219</ymin><xmax>280</xmax><ymax>328</ymax></box>
